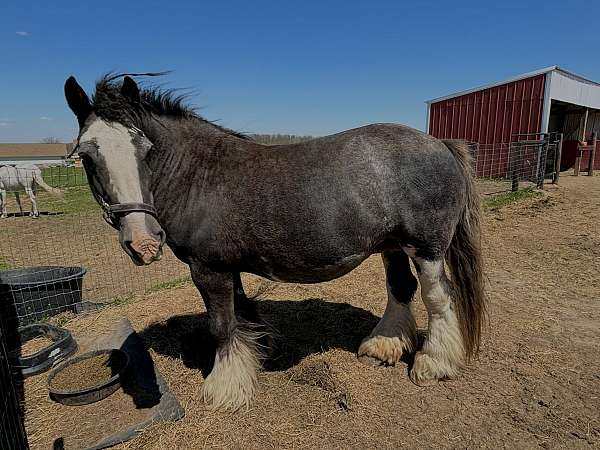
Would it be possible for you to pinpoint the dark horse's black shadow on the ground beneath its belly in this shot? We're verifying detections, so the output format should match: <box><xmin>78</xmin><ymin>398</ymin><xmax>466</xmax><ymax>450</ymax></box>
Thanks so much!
<box><xmin>140</xmin><ymin>299</ymin><xmax>379</xmax><ymax>376</ymax></box>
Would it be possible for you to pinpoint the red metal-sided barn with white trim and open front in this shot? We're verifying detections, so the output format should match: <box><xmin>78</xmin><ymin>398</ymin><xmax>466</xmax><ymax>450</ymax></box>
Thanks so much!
<box><xmin>426</xmin><ymin>66</ymin><xmax>600</xmax><ymax>175</ymax></box>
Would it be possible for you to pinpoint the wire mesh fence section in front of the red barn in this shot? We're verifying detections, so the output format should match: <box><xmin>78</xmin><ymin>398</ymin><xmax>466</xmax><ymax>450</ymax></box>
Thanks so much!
<box><xmin>470</xmin><ymin>130</ymin><xmax>561</xmax><ymax>194</ymax></box>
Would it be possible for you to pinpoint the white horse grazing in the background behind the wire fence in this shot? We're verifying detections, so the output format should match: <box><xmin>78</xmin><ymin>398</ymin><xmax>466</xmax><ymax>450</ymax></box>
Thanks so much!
<box><xmin>0</xmin><ymin>164</ymin><xmax>63</xmax><ymax>218</ymax></box>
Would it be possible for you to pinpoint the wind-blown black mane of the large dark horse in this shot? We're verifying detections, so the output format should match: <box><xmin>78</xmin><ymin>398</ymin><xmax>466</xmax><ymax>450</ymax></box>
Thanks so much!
<box><xmin>92</xmin><ymin>73</ymin><xmax>249</xmax><ymax>139</ymax></box>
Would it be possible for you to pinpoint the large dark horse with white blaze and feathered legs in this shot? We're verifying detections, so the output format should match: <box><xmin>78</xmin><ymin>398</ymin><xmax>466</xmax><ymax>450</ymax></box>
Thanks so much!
<box><xmin>64</xmin><ymin>73</ymin><xmax>486</xmax><ymax>410</ymax></box>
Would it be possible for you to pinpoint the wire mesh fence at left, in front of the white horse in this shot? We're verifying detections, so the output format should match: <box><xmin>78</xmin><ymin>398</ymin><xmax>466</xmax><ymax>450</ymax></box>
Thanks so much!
<box><xmin>0</xmin><ymin>164</ymin><xmax>188</xmax><ymax>325</ymax></box>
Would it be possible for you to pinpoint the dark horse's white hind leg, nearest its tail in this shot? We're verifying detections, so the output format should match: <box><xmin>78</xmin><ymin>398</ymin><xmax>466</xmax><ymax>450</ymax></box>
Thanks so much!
<box><xmin>410</xmin><ymin>257</ymin><xmax>465</xmax><ymax>384</ymax></box>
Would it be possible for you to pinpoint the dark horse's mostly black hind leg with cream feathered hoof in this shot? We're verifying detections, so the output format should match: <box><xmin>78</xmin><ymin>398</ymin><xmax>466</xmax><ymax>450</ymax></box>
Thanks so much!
<box><xmin>358</xmin><ymin>250</ymin><xmax>417</xmax><ymax>365</ymax></box>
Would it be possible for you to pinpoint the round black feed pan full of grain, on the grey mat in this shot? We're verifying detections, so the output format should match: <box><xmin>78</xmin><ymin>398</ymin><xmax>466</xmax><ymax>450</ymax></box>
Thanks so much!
<box><xmin>48</xmin><ymin>349</ymin><xmax>129</xmax><ymax>406</ymax></box>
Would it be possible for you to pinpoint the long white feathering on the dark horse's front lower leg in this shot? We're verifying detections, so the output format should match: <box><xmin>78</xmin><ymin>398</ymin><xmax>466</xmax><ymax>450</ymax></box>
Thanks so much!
<box><xmin>202</xmin><ymin>328</ymin><xmax>264</xmax><ymax>411</ymax></box>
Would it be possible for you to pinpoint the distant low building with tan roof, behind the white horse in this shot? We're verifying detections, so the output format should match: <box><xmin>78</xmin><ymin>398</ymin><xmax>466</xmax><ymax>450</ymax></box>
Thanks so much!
<box><xmin>0</xmin><ymin>143</ymin><xmax>73</xmax><ymax>166</ymax></box>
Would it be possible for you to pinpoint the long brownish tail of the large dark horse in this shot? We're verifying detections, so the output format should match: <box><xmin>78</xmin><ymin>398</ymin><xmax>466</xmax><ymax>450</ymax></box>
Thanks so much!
<box><xmin>443</xmin><ymin>140</ymin><xmax>486</xmax><ymax>360</ymax></box>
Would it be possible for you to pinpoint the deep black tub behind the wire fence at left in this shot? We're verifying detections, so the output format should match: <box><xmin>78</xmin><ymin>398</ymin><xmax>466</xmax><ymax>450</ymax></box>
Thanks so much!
<box><xmin>0</xmin><ymin>266</ymin><xmax>86</xmax><ymax>326</ymax></box>
